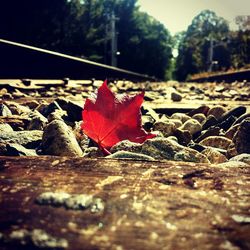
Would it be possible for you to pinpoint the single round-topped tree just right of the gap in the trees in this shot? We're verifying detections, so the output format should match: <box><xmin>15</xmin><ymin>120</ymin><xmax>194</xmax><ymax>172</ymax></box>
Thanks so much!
<box><xmin>176</xmin><ymin>10</ymin><xmax>230</xmax><ymax>80</ymax></box>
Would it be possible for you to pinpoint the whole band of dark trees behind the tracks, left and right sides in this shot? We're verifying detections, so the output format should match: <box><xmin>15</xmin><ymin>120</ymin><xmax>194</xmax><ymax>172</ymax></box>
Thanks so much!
<box><xmin>0</xmin><ymin>0</ymin><xmax>250</xmax><ymax>80</ymax></box>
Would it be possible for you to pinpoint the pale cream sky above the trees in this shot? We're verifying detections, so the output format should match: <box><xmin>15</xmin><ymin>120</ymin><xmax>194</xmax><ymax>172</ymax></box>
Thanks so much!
<box><xmin>138</xmin><ymin>0</ymin><xmax>250</xmax><ymax>35</ymax></box>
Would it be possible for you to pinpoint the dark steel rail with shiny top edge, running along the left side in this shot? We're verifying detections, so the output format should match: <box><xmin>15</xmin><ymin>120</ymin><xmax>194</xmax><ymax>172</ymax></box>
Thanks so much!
<box><xmin>0</xmin><ymin>39</ymin><xmax>156</xmax><ymax>81</ymax></box>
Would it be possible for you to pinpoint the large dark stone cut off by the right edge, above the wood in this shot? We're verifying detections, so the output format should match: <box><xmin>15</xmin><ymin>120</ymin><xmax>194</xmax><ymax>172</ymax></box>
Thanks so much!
<box><xmin>233</xmin><ymin>118</ymin><xmax>250</xmax><ymax>154</ymax></box>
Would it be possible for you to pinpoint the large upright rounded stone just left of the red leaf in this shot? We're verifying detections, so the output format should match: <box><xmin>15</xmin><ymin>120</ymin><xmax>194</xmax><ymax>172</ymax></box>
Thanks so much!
<box><xmin>42</xmin><ymin>120</ymin><xmax>83</xmax><ymax>156</ymax></box>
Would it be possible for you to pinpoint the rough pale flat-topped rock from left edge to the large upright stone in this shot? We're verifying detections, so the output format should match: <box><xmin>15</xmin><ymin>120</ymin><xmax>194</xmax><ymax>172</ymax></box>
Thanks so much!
<box><xmin>0</xmin><ymin>130</ymin><xmax>43</xmax><ymax>148</ymax></box>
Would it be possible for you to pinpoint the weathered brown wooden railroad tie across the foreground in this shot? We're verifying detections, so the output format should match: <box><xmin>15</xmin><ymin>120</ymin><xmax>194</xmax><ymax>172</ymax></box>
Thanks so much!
<box><xmin>0</xmin><ymin>157</ymin><xmax>250</xmax><ymax>250</ymax></box>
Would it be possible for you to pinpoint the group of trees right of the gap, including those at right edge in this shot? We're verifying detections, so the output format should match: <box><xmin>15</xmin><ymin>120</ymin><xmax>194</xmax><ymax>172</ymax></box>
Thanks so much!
<box><xmin>175</xmin><ymin>10</ymin><xmax>250</xmax><ymax>80</ymax></box>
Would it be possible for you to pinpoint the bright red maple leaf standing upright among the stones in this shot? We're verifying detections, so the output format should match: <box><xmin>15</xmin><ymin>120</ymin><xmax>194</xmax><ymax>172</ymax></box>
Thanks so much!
<box><xmin>81</xmin><ymin>81</ymin><xmax>156</xmax><ymax>153</ymax></box>
